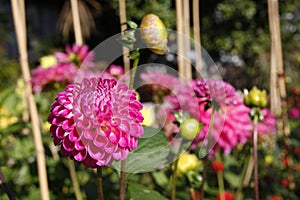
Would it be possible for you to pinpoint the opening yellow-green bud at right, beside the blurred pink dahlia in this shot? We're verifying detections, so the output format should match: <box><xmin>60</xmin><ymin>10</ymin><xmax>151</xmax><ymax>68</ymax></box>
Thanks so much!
<box><xmin>244</xmin><ymin>86</ymin><xmax>268</xmax><ymax>108</ymax></box>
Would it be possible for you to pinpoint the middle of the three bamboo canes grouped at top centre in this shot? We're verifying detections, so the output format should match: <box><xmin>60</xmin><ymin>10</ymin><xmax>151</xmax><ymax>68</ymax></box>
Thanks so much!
<box><xmin>183</xmin><ymin>0</ymin><xmax>192</xmax><ymax>80</ymax></box>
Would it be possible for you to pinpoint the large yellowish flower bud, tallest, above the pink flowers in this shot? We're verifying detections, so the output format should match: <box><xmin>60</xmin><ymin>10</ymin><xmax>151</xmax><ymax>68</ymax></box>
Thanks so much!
<box><xmin>140</xmin><ymin>14</ymin><xmax>168</xmax><ymax>55</ymax></box>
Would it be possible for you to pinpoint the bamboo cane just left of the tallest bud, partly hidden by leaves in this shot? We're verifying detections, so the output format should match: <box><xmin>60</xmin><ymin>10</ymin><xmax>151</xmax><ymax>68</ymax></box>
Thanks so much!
<box><xmin>119</xmin><ymin>0</ymin><xmax>130</xmax><ymax>73</ymax></box>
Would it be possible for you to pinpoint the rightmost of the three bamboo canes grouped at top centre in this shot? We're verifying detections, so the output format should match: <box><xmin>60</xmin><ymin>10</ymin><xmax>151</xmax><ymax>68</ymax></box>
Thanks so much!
<box><xmin>193</xmin><ymin>0</ymin><xmax>202</xmax><ymax>77</ymax></box>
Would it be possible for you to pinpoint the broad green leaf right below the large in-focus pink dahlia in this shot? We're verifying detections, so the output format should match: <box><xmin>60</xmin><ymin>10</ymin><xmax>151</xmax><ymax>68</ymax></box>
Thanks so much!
<box><xmin>112</xmin><ymin>127</ymin><xmax>170</xmax><ymax>173</ymax></box>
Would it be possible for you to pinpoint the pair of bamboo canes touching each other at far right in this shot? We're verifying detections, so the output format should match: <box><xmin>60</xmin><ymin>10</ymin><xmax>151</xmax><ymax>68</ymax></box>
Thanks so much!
<box><xmin>268</xmin><ymin>0</ymin><xmax>290</xmax><ymax>136</ymax></box>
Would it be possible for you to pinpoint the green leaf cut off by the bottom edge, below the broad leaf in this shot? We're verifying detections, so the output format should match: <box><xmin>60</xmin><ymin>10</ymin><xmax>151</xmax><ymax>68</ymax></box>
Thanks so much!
<box><xmin>128</xmin><ymin>183</ymin><xmax>168</xmax><ymax>200</ymax></box>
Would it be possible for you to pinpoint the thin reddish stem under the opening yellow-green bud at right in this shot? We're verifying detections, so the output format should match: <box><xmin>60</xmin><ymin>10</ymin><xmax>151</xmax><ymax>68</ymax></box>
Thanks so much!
<box><xmin>253</xmin><ymin>114</ymin><xmax>259</xmax><ymax>200</ymax></box>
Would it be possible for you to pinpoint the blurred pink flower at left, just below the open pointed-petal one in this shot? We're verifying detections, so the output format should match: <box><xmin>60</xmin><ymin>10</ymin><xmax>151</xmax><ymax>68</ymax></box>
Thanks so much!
<box><xmin>31</xmin><ymin>64</ymin><xmax>77</xmax><ymax>92</ymax></box>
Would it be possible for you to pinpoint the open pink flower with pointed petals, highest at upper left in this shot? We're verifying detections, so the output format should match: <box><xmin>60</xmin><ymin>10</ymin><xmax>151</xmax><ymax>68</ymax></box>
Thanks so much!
<box><xmin>54</xmin><ymin>44</ymin><xmax>95</xmax><ymax>67</ymax></box>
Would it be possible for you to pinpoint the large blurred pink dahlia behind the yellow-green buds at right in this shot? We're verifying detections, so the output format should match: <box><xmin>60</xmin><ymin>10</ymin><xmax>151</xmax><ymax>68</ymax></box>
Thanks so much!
<box><xmin>192</xmin><ymin>79</ymin><xmax>252</xmax><ymax>154</ymax></box>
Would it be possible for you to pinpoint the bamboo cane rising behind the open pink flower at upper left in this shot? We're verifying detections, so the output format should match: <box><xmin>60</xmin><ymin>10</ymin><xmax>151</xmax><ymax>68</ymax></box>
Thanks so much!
<box><xmin>71</xmin><ymin>0</ymin><xmax>83</xmax><ymax>45</ymax></box>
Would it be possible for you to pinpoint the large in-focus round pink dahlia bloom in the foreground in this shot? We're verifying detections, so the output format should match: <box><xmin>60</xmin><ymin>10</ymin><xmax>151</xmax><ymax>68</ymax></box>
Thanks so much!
<box><xmin>48</xmin><ymin>78</ymin><xmax>143</xmax><ymax>168</ymax></box>
